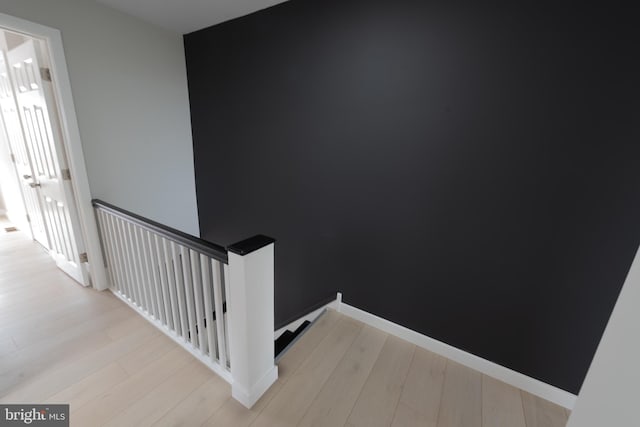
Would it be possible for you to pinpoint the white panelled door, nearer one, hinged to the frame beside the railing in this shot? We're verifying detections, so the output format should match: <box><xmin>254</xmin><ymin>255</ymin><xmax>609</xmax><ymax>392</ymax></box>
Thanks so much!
<box><xmin>7</xmin><ymin>40</ymin><xmax>88</xmax><ymax>285</ymax></box>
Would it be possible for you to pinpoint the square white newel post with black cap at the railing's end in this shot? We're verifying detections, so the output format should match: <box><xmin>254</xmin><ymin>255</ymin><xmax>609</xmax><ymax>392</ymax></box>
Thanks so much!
<box><xmin>227</xmin><ymin>235</ymin><xmax>278</xmax><ymax>408</ymax></box>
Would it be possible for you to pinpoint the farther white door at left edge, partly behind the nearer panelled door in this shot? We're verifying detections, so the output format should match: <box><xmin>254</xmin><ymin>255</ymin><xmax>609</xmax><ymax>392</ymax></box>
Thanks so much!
<box><xmin>0</xmin><ymin>50</ymin><xmax>49</xmax><ymax>248</ymax></box>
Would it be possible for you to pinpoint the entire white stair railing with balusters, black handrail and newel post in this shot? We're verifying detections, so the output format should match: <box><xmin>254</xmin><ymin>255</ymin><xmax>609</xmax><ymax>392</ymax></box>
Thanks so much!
<box><xmin>93</xmin><ymin>200</ymin><xmax>278</xmax><ymax>408</ymax></box>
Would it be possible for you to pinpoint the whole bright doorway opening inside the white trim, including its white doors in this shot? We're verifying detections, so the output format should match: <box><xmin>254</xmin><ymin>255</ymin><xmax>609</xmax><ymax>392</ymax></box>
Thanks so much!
<box><xmin>0</xmin><ymin>28</ymin><xmax>95</xmax><ymax>286</ymax></box>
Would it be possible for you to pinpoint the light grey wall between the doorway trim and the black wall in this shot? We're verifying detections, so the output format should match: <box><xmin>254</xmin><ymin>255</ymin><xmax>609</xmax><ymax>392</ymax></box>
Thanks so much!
<box><xmin>0</xmin><ymin>0</ymin><xmax>199</xmax><ymax>235</ymax></box>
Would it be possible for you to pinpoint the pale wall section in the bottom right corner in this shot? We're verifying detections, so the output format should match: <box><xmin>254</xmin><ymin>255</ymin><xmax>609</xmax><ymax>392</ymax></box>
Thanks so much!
<box><xmin>567</xmin><ymin>247</ymin><xmax>640</xmax><ymax>427</ymax></box>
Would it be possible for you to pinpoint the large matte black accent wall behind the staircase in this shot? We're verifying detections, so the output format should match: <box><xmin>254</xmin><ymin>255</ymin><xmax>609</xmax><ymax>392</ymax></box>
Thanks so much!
<box><xmin>185</xmin><ymin>0</ymin><xmax>640</xmax><ymax>393</ymax></box>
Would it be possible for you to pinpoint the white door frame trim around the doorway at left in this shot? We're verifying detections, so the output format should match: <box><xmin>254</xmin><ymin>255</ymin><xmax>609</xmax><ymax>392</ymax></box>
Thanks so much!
<box><xmin>0</xmin><ymin>13</ymin><xmax>109</xmax><ymax>290</ymax></box>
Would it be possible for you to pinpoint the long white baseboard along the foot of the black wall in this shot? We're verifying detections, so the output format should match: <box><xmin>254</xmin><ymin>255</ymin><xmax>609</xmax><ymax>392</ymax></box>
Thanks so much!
<box><xmin>335</xmin><ymin>294</ymin><xmax>577</xmax><ymax>409</ymax></box>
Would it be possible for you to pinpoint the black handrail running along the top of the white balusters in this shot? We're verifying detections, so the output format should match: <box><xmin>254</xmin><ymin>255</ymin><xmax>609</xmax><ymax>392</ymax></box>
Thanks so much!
<box><xmin>91</xmin><ymin>199</ymin><xmax>229</xmax><ymax>264</ymax></box>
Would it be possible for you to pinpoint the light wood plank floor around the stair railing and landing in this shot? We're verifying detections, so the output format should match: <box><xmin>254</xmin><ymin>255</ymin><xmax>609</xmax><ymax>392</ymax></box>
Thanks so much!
<box><xmin>0</xmin><ymin>224</ymin><xmax>568</xmax><ymax>427</ymax></box>
